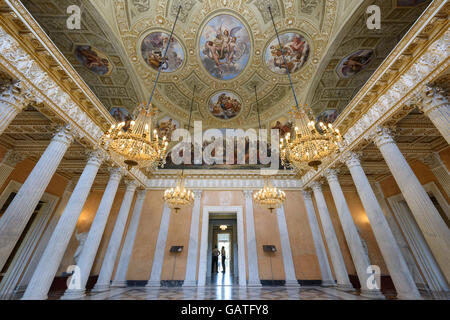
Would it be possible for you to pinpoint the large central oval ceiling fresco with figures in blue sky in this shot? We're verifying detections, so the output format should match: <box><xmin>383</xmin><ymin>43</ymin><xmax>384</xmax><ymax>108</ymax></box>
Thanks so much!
<box><xmin>199</xmin><ymin>14</ymin><xmax>251</xmax><ymax>80</ymax></box>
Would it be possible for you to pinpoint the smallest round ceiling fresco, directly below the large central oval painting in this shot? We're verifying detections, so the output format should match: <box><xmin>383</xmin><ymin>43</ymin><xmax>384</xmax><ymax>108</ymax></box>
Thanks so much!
<box><xmin>208</xmin><ymin>91</ymin><xmax>242</xmax><ymax>120</ymax></box>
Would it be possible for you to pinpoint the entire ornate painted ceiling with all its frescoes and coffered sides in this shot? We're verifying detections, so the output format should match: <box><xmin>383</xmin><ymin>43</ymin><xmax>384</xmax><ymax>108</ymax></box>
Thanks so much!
<box><xmin>23</xmin><ymin>0</ymin><xmax>428</xmax><ymax>128</ymax></box>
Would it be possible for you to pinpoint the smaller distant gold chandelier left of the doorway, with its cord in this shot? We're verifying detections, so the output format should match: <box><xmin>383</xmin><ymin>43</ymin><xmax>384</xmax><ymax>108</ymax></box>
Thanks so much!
<box><xmin>163</xmin><ymin>85</ymin><xmax>197</xmax><ymax>213</ymax></box>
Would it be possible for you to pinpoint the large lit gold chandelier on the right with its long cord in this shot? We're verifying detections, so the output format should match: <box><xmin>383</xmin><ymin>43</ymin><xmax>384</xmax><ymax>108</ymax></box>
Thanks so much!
<box><xmin>268</xmin><ymin>6</ymin><xmax>343</xmax><ymax>174</ymax></box>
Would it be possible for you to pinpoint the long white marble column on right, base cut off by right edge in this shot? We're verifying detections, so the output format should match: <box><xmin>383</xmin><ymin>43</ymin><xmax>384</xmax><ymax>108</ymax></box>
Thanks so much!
<box><xmin>374</xmin><ymin>127</ymin><xmax>450</xmax><ymax>282</ymax></box>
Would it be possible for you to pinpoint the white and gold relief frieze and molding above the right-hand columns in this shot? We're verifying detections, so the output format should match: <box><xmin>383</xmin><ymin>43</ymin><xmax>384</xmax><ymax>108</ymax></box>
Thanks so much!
<box><xmin>301</xmin><ymin>12</ymin><xmax>450</xmax><ymax>186</ymax></box>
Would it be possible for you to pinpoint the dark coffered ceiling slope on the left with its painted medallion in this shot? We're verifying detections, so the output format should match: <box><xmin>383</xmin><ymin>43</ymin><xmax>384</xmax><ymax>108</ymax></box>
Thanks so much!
<box><xmin>22</xmin><ymin>0</ymin><xmax>143</xmax><ymax>111</ymax></box>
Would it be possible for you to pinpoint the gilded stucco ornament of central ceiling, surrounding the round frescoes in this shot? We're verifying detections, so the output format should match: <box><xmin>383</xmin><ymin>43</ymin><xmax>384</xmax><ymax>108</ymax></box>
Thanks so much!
<box><xmin>114</xmin><ymin>0</ymin><xmax>337</xmax><ymax>128</ymax></box>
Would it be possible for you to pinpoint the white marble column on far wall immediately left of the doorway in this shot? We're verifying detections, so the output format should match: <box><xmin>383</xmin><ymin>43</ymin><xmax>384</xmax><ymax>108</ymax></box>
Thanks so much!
<box><xmin>183</xmin><ymin>190</ymin><xmax>203</xmax><ymax>287</ymax></box>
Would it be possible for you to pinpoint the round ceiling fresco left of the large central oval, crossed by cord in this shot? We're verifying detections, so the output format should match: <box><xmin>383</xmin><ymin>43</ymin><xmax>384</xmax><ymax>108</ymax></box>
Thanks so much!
<box><xmin>141</xmin><ymin>32</ymin><xmax>184</xmax><ymax>72</ymax></box>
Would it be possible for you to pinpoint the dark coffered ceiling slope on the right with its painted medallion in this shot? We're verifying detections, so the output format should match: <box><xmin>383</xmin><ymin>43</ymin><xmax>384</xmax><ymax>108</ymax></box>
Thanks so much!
<box><xmin>307</xmin><ymin>0</ymin><xmax>430</xmax><ymax>121</ymax></box>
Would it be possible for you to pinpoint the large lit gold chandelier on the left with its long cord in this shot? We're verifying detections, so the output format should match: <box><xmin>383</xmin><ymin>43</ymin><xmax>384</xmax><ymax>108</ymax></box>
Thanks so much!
<box><xmin>100</xmin><ymin>6</ymin><xmax>181</xmax><ymax>170</ymax></box>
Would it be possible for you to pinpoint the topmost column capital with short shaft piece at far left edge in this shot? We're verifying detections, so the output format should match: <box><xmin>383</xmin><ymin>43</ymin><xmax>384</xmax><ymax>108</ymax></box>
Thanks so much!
<box><xmin>0</xmin><ymin>83</ymin><xmax>30</xmax><ymax>135</ymax></box>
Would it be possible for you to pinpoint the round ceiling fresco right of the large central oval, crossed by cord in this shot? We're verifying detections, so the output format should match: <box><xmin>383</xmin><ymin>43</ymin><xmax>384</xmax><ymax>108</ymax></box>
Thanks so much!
<box><xmin>264</xmin><ymin>32</ymin><xmax>310</xmax><ymax>74</ymax></box>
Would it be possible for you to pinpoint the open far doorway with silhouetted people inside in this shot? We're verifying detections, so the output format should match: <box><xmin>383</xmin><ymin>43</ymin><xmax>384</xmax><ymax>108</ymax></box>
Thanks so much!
<box><xmin>207</xmin><ymin>214</ymin><xmax>238</xmax><ymax>286</ymax></box>
